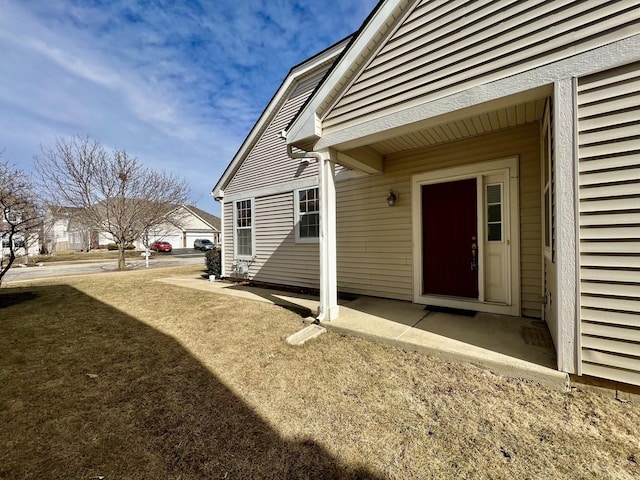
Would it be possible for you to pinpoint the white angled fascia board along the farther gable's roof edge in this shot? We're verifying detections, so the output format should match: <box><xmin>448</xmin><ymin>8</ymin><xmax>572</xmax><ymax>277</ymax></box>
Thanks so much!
<box><xmin>211</xmin><ymin>39</ymin><xmax>349</xmax><ymax>199</ymax></box>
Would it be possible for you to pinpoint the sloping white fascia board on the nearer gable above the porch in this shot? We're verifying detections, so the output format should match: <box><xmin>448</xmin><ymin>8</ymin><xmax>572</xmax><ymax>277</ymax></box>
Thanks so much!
<box><xmin>287</xmin><ymin>0</ymin><xmax>410</xmax><ymax>144</ymax></box>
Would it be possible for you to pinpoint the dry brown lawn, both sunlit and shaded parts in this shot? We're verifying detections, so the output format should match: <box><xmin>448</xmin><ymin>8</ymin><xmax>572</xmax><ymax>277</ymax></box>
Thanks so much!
<box><xmin>0</xmin><ymin>267</ymin><xmax>640</xmax><ymax>480</ymax></box>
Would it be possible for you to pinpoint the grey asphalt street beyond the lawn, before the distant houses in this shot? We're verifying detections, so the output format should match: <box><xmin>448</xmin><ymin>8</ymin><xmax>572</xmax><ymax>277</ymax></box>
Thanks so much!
<box><xmin>2</xmin><ymin>249</ymin><xmax>204</xmax><ymax>283</ymax></box>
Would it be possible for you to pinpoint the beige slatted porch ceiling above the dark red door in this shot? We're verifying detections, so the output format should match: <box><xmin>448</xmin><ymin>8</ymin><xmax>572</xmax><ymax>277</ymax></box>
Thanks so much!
<box><xmin>369</xmin><ymin>98</ymin><xmax>546</xmax><ymax>156</ymax></box>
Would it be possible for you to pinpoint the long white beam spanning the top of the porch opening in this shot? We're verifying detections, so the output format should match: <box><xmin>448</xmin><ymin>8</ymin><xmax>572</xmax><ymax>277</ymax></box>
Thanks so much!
<box><xmin>314</xmin><ymin>35</ymin><xmax>640</xmax><ymax>150</ymax></box>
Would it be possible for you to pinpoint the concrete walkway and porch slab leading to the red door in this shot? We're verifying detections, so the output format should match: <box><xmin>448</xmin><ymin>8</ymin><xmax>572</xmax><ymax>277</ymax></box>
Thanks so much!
<box><xmin>158</xmin><ymin>277</ymin><xmax>569</xmax><ymax>390</ymax></box>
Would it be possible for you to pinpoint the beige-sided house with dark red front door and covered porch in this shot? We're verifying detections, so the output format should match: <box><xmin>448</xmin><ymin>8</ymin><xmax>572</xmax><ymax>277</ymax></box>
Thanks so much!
<box><xmin>212</xmin><ymin>0</ymin><xmax>640</xmax><ymax>385</ymax></box>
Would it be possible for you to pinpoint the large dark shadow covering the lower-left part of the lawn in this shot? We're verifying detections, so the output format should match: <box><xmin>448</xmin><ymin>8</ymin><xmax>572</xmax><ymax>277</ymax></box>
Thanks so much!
<box><xmin>0</xmin><ymin>285</ymin><xmax>376</xmax><ymax>480</ymax></box>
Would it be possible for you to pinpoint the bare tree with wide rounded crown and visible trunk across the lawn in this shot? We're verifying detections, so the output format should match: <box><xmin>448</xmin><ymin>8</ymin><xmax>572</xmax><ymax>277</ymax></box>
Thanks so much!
<box><xmin>35</xmin><ymin>136</ymin><xmax>188</xmax><ymax>270</ymax></box>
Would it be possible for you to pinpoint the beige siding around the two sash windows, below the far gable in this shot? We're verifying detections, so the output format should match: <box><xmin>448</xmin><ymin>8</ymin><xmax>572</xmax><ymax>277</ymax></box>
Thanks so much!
<box><xmin>224</xmin><ymin>192</ymin><xmax>320</xmax><ymax>288</ymax></box>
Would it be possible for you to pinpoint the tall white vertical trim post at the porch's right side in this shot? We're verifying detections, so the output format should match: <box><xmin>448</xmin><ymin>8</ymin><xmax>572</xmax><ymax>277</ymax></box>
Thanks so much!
<box><xmin>553</xmin><ymin>78</ymin><xmax>580</xmax><ymax>373</ymax></box>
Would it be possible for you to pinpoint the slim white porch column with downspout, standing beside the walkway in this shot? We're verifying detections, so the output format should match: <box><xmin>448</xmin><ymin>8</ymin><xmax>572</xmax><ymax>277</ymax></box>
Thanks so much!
<box><xmin>318</xmin><ymin>151</ymin><xmax>339</xmax><ymax>321</ymax></box>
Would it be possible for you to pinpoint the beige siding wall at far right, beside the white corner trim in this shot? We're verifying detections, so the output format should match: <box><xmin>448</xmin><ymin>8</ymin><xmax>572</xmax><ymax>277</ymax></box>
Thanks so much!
<box><xmin>577</xmin><ymin>63</ymin><xmax>640</xmax><ymax>385</ymax></box>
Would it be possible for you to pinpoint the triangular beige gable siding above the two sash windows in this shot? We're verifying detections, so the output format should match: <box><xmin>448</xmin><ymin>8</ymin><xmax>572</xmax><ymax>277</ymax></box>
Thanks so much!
<box><xmin>225</xmin><ymin>69</ymin><xmax>326</xmax><ymax>195</ymax></box>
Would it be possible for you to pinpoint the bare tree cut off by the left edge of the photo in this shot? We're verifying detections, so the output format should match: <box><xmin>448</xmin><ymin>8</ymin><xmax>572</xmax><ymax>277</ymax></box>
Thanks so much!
<box><xmin>0</xmin><ymin>152</ymin><xmax>42</xmax><ymax>285</ymax></box>
